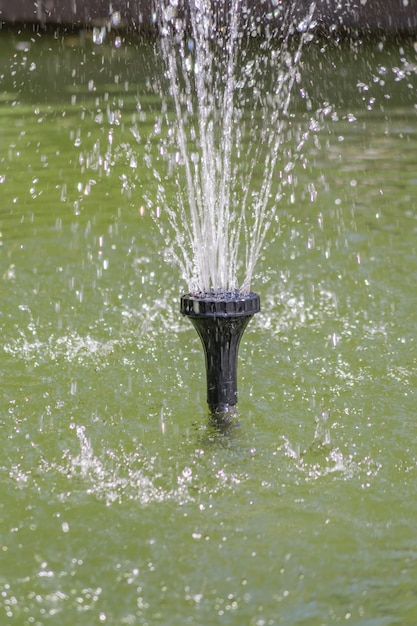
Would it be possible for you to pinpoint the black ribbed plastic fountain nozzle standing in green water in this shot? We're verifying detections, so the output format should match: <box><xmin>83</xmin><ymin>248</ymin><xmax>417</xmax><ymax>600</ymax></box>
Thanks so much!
<box><xmin>181</xmin><ymin>293</ymin><xmax>260</xmax><ymax>416</ymax></box>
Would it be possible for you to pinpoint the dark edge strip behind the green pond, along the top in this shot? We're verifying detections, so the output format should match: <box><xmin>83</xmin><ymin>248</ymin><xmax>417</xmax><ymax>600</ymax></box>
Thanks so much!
<box><xmin>0</xmin><ymin>0</ymin><xmax>417</xmax><ymax>34</ymax></box>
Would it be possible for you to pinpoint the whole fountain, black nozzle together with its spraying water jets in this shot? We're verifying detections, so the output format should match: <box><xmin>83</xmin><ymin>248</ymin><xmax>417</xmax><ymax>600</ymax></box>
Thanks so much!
<box><xmin>154</xmin><ymin>0</ymin><xmax>315</xmax><ymax>416</ymax></box>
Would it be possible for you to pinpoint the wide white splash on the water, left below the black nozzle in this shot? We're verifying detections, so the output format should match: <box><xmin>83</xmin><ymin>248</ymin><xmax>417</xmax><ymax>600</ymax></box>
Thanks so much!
<box><xmin>22</xmin><ymin>423</ymin><xmax>248</xmax><ymax>507</ymax></box>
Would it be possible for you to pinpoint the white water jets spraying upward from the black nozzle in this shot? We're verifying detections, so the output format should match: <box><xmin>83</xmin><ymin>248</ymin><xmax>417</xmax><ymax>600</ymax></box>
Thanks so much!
<box><xmin>148</xmin><ymin>0</ymin><xmax>315</xmax><ymax>295</ymax></box>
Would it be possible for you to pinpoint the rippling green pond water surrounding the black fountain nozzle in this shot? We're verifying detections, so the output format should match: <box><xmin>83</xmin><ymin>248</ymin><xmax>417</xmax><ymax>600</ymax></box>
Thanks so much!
<box><xmin>0</xmin><ymin>26</ymin><xmax>417</xmax><ymax>626</ymax></box>
